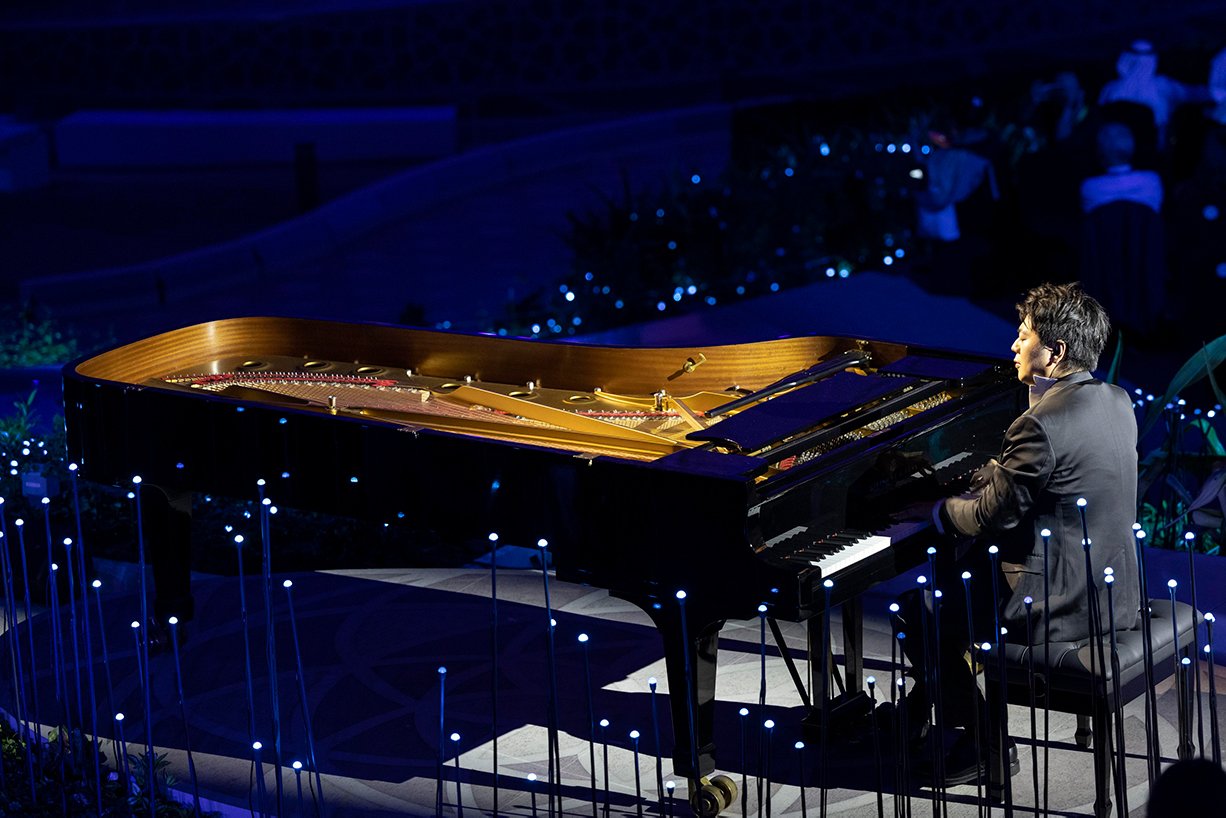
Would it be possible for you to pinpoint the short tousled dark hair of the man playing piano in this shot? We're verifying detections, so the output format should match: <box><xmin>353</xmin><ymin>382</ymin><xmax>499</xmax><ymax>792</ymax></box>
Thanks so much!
<box><xmin>1018</xmin><ymin>281</ymin><xmax>1111</xmax><ymax>369</ymax></box>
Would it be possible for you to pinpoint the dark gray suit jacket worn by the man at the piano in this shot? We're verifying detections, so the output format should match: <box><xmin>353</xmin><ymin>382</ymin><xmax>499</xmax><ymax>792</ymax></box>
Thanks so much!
<box><xmin>944</xmin><ymin>372</ymin><xmax>1140</xmax><ymax>641</ymax></box>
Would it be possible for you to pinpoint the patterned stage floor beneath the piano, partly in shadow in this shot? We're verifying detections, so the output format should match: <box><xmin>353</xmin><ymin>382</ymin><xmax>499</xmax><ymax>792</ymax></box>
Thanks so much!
<box><xmin>19</xmin><ymin>567</ymin><xmax>1226</xmax><ymax>817</ymax></box>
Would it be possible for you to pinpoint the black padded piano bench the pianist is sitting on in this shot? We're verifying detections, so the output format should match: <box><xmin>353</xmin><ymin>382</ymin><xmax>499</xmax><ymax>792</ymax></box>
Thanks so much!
<box><xmin>986</xmin><ymin>600</ymin><xmax>1203</xmax><ymax>818</ymax></box>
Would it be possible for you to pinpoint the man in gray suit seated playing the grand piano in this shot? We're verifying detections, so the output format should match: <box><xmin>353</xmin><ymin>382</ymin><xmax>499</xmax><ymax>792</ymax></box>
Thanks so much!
<box><xmin>904</xmin><ymin>283</ymin><xmax>1139</xmax><ymax>784</ymax></box>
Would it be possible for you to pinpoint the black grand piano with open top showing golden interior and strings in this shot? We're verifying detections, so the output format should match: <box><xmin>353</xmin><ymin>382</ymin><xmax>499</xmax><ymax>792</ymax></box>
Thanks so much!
<box><xmin>64</xmin><ymin>318</ymin><xmax>1022</xmax><ymax>816</ymax></box>
